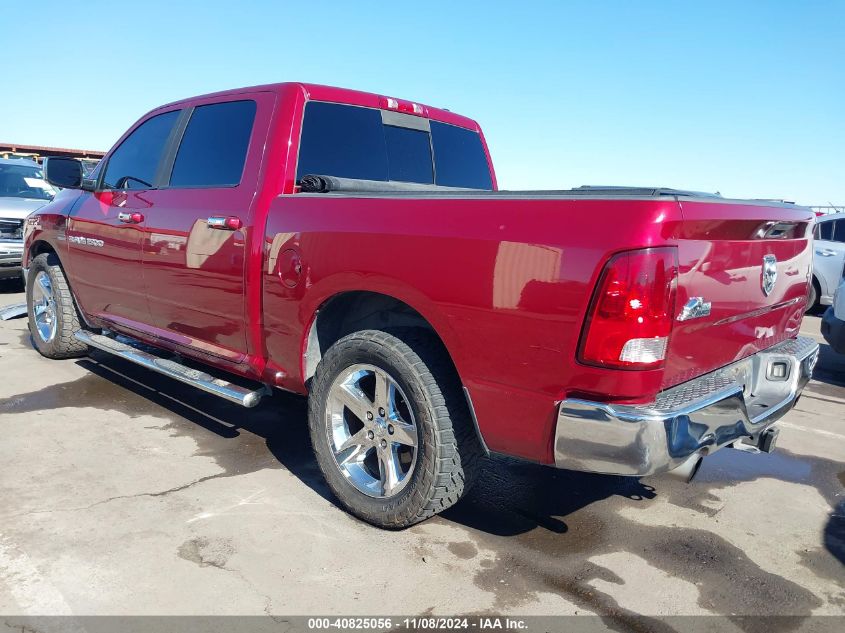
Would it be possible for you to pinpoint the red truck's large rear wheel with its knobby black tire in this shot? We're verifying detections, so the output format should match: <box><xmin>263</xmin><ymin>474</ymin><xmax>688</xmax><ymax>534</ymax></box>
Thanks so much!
<box><xmin>308</xmin><ymin>330</ymin><xmax>482</xmax><ymax>528</ymax></box>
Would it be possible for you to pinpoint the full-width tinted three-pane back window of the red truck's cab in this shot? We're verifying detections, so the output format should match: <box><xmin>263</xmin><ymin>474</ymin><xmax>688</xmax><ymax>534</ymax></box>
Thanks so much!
<box><xmin>296</xmin><ymin>101</ymin><xmax>492</xmax><ymax>189</ymax></box>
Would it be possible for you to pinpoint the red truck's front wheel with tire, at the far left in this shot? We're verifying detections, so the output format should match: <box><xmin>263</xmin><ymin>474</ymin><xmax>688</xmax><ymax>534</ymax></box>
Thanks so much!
<box><xmin>26</xmin><ymin>253</ymin><xmax>88</xmax><ymax>359</ymax></box>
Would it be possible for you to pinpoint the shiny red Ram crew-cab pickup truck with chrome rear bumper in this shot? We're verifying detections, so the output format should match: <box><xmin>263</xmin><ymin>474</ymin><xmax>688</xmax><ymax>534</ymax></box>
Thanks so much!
<box><xmin>24</xmin><ymin>83</ymin><xmax>818</xmax><ymax>527</ymax></box>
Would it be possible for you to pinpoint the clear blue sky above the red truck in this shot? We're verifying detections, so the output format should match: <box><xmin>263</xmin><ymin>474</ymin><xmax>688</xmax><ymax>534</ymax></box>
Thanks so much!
<box><xmin>0</xmin><ymin>0</ymin><xmax>845</xmax><ymax>204</ymax></box>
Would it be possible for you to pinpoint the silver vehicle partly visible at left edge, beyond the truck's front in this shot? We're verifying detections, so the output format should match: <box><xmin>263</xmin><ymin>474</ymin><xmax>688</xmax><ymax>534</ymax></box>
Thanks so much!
<box><xmin>0</xmin><ymin>158</ymin><xmax>57</xmax><ymax>280</ymax></box>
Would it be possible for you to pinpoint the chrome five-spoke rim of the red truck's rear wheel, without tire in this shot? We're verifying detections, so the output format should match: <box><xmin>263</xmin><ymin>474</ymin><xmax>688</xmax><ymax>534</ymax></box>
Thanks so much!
<box><xmin>326</xmin><ymin>365</ymin><xmax>419</xmax><ymax>498</ymax></box>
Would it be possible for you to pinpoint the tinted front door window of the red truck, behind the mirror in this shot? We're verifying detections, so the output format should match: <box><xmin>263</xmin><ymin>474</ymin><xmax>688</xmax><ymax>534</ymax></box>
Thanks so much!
<box><xmin>102</xmin><ymin>110</ymin><xmax>179</xmax><ymax>189</ymax></box>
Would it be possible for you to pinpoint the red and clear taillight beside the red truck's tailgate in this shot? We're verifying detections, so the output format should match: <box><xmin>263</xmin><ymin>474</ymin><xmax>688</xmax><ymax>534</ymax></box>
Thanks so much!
<box><xmin>578</xmin><ymin>247</ymin><xmax>678</xmax><ymax>369</ymax></box>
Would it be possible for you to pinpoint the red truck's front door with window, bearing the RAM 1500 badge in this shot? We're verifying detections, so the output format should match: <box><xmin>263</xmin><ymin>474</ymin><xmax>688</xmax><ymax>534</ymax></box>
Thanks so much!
<box><xmin>66</xmin><ymin>110</ymin><xmax>180</xmax><ymax>330</ymax></box>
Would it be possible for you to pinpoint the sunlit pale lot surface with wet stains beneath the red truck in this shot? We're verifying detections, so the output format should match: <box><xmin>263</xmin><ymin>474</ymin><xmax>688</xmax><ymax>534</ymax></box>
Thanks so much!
<box><xmin>0</xmin><ymin>288</ymin><xmax>845</xmax><ymax>630</ymax></box>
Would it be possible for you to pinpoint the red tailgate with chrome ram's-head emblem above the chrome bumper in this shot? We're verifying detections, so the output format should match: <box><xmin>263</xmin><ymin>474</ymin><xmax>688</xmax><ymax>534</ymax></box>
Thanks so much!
<box><xmin>663</xmin><ymin>199</ymin><xmax>813</xmax><ymax>387</ymax></box>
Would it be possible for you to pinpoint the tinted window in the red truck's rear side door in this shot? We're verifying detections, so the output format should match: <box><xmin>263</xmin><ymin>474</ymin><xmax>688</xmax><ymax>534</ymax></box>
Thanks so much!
<box><xmin>170</xmin><ymin>101</ymin><xmax>255</xmax><ymax>187</ymax></box>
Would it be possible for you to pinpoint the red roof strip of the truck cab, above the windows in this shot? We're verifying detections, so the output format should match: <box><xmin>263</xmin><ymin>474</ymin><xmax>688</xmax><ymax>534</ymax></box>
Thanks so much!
<box><xmin>156</xmin><ymin>81</ymin><xmax>481</xmax><ymax>132</ymax></box>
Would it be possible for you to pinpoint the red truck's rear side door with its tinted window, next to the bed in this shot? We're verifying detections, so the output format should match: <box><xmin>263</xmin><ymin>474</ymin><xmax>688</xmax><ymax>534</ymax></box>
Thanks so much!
<box><xmin>142</xmin><ymin>93</ymin><xmax>275</xmax><ymax>363</ymax></box>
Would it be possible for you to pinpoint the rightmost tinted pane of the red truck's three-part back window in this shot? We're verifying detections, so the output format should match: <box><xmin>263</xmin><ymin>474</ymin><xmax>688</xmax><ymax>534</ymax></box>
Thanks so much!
<box><xmin>431</xmin><ymin>121</ymin><xmax>493</xmax><ymax>189</ymax></box>
